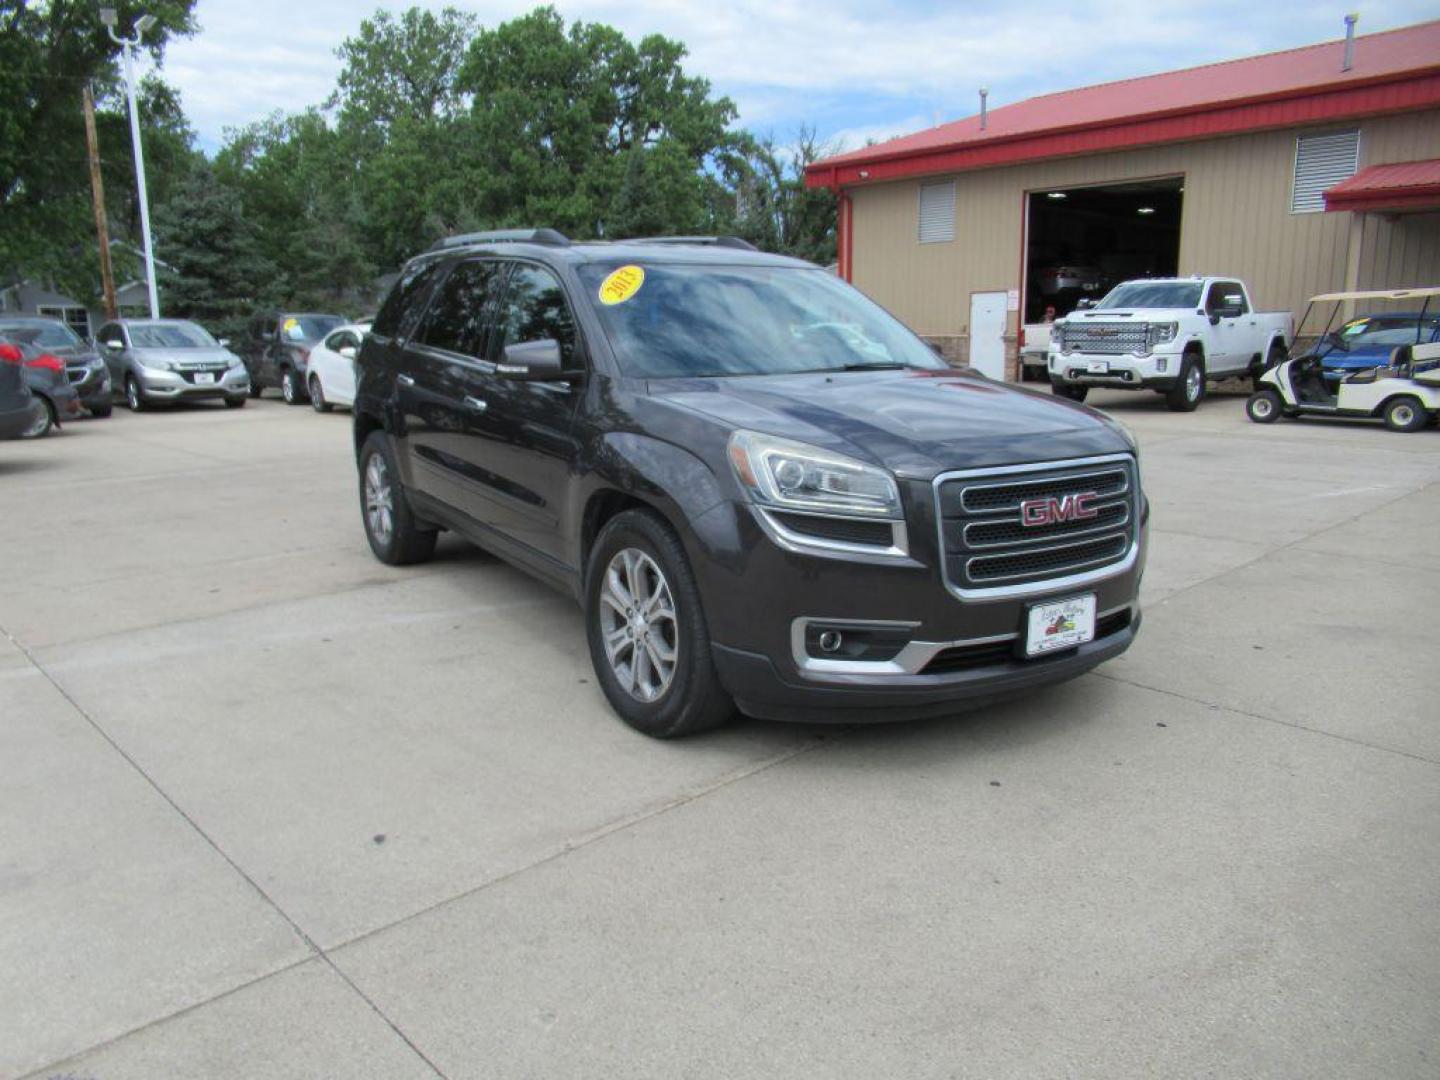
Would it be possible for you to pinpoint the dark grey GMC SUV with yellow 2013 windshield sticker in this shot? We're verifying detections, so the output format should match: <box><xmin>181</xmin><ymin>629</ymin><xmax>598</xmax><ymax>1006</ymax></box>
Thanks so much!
<box><xmin>354</xmin><ymin>229</ymin><xmax>1148</xmax><ymax>737</ymax></box>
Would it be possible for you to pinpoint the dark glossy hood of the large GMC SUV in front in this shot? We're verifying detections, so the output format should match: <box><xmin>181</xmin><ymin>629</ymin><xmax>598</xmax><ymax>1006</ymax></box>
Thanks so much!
<box><xmin>649</xmin><ymin>370</ymin><xmax>1132</xmax><ymax>480</ymax></box>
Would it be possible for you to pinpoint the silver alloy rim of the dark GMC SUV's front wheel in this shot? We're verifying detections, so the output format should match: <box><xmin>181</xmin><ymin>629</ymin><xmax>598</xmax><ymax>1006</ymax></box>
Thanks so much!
<box><xmin>599</xmin><ymin>547</ymin><xmax>680</xmax><ymax>703</ymax></box>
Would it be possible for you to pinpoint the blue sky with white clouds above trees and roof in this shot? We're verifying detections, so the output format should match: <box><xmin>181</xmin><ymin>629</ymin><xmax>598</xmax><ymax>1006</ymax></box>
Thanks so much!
<box><xmin>149</xmin><ymin>0</ymin><xmax>1437</xmax><ymax>151</ymax></box>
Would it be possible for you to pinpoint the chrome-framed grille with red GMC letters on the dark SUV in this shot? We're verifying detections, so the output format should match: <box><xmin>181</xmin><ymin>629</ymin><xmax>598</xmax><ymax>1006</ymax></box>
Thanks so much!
<box><xmin>936</xmin><ymin>455</ymin><xmax>1139</xmax><ymax>595</ymax></box>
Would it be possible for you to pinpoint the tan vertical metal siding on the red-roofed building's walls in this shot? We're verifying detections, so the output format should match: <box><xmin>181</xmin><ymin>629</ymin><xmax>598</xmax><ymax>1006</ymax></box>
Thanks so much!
<box><xmin>851</xmin><ymin>111</ymin><xmax>1440</xmax><ymax>348</ymax></box>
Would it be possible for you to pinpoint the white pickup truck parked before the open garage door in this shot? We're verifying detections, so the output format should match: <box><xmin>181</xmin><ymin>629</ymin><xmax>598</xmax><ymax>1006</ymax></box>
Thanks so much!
<box><xmin>1047</xmin><ymin>278</ymin><xmax>1295</xmax><ymax>412</ymax></box>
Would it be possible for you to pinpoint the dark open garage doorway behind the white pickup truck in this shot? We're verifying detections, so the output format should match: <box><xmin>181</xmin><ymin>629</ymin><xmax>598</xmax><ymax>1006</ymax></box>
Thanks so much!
<box><xmin>1022</xmin><ymin>176</ymin><xmax>1185</xmax><ymax>325</ymax></box>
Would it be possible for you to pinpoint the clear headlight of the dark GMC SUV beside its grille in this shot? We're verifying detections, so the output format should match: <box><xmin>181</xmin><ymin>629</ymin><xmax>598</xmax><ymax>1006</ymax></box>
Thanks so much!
<box><xmin>730</xmin><ymin>431</ymin><xmax>901</xmax><ymax>518</ymax></box>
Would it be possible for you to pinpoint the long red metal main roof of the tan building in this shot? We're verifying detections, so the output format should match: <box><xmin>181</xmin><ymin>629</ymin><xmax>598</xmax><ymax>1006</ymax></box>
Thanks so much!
<box><xmin>805</xmin><ymin>20</ymin><xmax>1440</xmax><ymax>187</ymax></box>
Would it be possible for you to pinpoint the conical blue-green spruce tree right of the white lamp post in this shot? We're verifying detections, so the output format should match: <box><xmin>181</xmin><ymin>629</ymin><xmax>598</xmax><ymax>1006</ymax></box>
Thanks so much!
<box><xmin>156</xmin><ymin>164</ymin><xmax>284</xmax><ymax>336</ymax></box>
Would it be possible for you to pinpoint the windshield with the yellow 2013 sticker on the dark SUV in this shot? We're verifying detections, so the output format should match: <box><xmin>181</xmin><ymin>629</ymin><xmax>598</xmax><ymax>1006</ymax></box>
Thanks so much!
<box><xmin>579</xmin><ymin>264</ymin><xmax>946</xmax><ymax>379</ymax></box>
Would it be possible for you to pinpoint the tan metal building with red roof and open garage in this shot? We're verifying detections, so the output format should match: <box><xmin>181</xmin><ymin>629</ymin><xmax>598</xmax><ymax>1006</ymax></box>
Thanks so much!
<box><xmin>806</xmin><ymin>22</ymin><xmax>1440</xmax><ymax>377</ymax></box>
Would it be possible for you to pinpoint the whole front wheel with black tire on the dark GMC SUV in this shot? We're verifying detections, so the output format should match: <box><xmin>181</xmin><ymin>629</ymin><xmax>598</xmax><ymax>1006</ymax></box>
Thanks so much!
<box><xmin>585</xmin><ymin>510</ymin><xmax>734</xmax><ymax>739</ymax></box>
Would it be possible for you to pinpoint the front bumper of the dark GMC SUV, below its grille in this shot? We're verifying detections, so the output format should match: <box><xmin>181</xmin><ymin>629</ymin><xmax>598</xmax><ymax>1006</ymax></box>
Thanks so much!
<box><xmin>687</xmin><ymin>482</ymin><xmax>1148</xmax><ymax>723</ymax></box>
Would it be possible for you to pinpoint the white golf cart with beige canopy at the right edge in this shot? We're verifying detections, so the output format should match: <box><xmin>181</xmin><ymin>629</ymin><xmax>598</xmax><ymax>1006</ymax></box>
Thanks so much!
<box><xmin>1246</xmin><ymin>292</ymin><xmax>1440</xmax><ymax>431</ymax></box>
